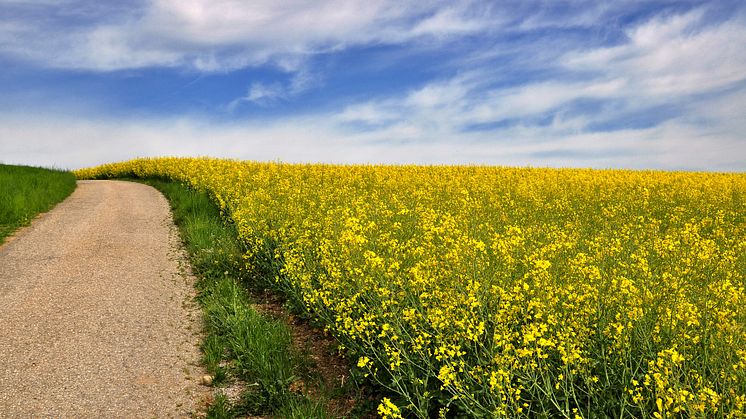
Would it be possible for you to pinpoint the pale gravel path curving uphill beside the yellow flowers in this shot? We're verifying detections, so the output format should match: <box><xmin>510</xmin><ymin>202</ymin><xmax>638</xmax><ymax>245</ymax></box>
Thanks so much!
<box><xmin>0</xmin><ymin>181</ymin><xmax>206</xmax><ymax>418</ymax></box>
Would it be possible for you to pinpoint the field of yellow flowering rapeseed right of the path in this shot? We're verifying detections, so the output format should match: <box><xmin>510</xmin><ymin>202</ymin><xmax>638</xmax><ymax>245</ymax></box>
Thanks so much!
<box><xmin>77</xmin><ymin>158</ymin><xmax>746</xmax><ymax>418</ymax></box>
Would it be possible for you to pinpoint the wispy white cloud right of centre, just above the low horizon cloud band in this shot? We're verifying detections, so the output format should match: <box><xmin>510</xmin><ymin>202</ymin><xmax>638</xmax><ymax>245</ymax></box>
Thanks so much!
<box><xmin>334</xmin><ymin>72</ymin><xmax>626</xmax><ymax>137</ymax></box>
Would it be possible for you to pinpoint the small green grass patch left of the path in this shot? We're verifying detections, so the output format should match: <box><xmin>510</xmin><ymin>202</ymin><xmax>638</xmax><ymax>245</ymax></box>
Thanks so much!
<box><xmin>0</xmin><ymin>164</ymin><xmax>75</xmax><ymax>243</ymax></box>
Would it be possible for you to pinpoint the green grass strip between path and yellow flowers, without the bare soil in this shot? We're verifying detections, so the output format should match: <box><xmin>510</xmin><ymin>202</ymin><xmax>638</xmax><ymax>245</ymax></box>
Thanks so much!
<box><xmin>137</xmin><ymin>179</ymin><xmax>364</xmax><ymax>418</ymax></box>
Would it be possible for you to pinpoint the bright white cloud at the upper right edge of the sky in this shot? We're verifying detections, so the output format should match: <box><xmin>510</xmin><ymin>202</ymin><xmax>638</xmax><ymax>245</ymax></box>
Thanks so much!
<box><xmin>563</xmin><ymin>10</ymin><xmax>746</xmax><ymax>100</ymax></box>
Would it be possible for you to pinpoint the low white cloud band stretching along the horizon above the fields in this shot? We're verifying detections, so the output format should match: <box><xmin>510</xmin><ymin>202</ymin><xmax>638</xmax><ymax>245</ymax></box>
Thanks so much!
<box><xmin>0</xmin><ymin>104</ymin><xmax>746</xmax><ymax>171</ymax></box>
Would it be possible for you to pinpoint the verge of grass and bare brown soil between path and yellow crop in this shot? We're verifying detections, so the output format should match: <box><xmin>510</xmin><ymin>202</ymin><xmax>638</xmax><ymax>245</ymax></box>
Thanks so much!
<box><xmin>137</xmin><ymin>179</ymin><xmax>374</xmax><ymax>418</ymax></box>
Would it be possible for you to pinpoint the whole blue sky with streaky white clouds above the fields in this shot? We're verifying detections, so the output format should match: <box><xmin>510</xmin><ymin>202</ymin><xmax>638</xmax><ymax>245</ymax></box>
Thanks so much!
<box><xmin>0</xmin><ymin>0</ymin><xmax>746</xmax><ymax>172</ymax></box>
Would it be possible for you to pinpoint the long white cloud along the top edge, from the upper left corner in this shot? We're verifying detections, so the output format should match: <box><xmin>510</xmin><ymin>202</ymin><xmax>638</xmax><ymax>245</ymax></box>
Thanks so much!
<box><xmin>0</xmin><ymin>0</ymin><xmax>491</xmax><ymax>71</ymax></box>
